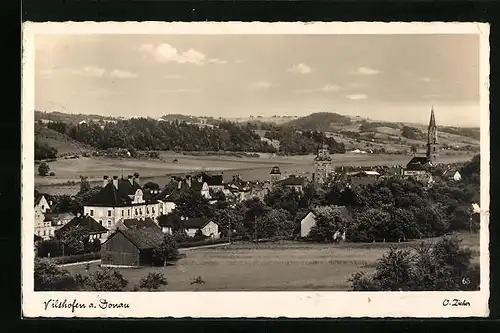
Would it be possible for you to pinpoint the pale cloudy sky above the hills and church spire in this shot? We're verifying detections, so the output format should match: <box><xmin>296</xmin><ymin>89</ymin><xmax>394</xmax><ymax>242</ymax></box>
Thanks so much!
<box><xmin>35</xmin><ymin>34</ymin><xmax>480</xmax><ymax>126</ymax></box>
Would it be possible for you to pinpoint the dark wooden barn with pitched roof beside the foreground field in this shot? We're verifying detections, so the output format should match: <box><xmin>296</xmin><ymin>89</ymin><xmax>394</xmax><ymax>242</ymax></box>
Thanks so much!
<box><xmin>101</xmin><ymin>228</ymin><xmax>164</xmax><ymax>267</ymax></box>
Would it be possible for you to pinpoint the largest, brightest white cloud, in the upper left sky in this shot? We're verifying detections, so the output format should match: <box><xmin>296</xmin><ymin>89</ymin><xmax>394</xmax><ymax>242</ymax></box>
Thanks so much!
<box><xmin>139</xmin><ymin>43</ymin><xmax>227</xmax><ymax>66</ymax></box>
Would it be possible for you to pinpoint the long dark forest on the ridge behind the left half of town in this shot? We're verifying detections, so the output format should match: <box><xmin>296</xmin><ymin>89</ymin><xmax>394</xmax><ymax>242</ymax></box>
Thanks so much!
<box><xmin>47</xmin><ymin>118</ymin><xmax>276</xmax><ymax>152</ymax></box>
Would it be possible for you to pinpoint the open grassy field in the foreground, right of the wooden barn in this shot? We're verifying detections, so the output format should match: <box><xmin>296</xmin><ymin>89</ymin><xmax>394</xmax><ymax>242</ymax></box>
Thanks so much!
<box><xmin>66</xmin><ymin>234</ymin><xmax>479</xmax><ymax>291</ymax></box>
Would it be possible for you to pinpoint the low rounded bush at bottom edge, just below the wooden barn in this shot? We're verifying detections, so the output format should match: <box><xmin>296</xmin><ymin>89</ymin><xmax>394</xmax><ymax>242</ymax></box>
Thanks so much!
<box><xmin>75</xmin><ymin>268</ymin><xmax>128</xmax><ymax>291</ymax></box>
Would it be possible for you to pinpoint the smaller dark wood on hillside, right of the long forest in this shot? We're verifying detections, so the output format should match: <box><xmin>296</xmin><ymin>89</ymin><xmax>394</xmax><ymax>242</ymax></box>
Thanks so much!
<box><xmin>264</xmin><ymin>127</ymin><xmax>345</xmax><ymax>154</ymax></box>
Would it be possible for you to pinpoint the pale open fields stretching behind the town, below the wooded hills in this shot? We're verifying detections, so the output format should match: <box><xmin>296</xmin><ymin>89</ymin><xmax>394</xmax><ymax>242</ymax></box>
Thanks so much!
<box><xmin>35</xmin><ymin>152</ymin><xmax>473</xmax><ymax>194</ymax></box>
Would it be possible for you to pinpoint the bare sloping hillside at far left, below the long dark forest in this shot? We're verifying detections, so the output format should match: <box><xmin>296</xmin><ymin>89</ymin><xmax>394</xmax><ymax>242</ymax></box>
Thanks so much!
<box><xmin>35</xmin><ymin>125</ymin><xmax>96</xmax><ymax>156</ymax></box>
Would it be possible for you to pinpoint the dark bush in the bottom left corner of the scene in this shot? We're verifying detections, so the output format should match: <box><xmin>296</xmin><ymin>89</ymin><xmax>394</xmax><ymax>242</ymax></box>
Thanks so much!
<box><xmin>34</xmin><ymin>258</ymin><xmax>78</xmax><ymax>291</ymax></box>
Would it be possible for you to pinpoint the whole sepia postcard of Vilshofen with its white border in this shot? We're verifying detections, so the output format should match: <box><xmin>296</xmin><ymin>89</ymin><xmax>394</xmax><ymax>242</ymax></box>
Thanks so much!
<box><xmin>22</xmin><ymin>22</ymin><xmax>490</xmax><ymax>318</ymax></box>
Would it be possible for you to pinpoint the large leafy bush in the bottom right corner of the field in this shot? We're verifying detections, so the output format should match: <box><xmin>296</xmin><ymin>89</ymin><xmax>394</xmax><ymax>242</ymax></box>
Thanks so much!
<box><xmin>349</xmin><ymin>233</ymin><xmax>480</xmax><ymax>291</ymax></box>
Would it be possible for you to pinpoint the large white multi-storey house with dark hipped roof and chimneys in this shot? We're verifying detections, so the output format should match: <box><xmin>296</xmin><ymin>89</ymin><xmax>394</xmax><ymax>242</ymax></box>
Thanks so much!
<box><xmin>84</xmin><ymin>173</ymin><xmax>168</xmax><ymax>230</ymax></box>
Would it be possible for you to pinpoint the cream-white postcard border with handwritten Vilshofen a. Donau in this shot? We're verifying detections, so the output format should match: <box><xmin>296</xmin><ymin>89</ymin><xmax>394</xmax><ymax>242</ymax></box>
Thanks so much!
<box><xmin>21</xmin><ymin>22</ymin><xmax>490</xmax><ymax>318</ymax></box>
